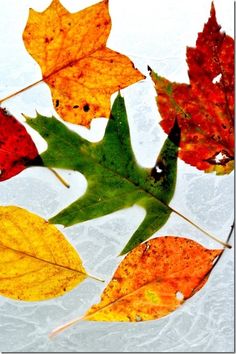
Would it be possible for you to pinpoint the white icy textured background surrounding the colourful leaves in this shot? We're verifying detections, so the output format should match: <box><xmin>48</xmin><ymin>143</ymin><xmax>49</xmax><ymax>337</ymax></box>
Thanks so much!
<box><xmin>0</xmin><ymin>0</ymin><xmax>233</xmax><ymax>352</ymax></box>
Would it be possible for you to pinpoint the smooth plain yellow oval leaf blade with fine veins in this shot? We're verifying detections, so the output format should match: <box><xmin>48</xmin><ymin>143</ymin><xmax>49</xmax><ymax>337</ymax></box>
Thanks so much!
<box><xmin>0</xmin><ymin>206</ymin><xmax>87</xmax><ymax>301</ymax></box>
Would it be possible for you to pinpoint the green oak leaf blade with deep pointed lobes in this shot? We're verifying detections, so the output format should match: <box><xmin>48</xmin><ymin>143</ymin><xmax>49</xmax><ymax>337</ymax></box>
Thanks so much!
<box><xmin>27</xmin><ymin>94</ymin><xmax>180</xmax><ymax>254</ymax></box>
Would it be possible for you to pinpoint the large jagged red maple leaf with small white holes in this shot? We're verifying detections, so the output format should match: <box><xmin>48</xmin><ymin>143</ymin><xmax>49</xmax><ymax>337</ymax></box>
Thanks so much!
<box><xmin>150</xmin><ymin>3</ymin><xmax>234</xmax><ymax>174</ymax></box>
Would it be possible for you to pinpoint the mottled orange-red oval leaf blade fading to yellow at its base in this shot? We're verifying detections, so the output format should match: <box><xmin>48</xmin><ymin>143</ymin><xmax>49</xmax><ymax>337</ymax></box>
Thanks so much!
<box><xmin>84</xmin><ymin>236</ymin><xmax>222</xmax><ymax>322</ymax></box>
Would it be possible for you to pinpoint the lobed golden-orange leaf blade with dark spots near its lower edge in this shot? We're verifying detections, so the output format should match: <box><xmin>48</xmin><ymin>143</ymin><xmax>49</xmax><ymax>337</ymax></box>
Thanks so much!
<box><xmin>23</xmin><ymin>0</ymin><xmax>144</xmax><ymax>126</ymax></box>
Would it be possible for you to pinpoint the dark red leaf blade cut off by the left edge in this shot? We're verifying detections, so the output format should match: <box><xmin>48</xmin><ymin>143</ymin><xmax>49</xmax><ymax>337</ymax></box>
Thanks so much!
<box><xmin>0</xmin><ymin>108</ymin><xmax>41</xmax><ymax>181</ymax></box>
